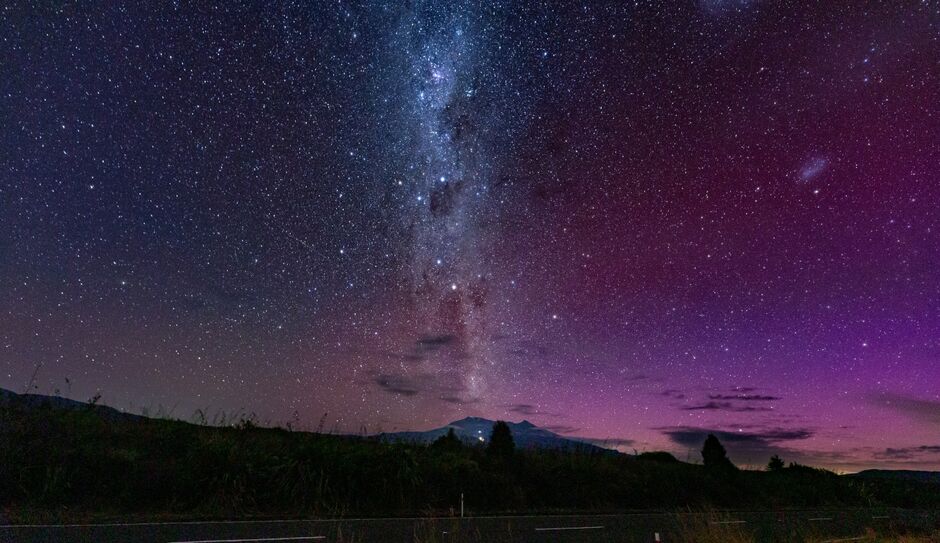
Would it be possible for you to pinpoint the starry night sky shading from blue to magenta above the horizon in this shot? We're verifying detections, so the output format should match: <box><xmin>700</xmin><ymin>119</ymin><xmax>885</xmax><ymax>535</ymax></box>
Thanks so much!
<box><xmin>0</xmin><ymin>0</ymin><xmax>940</xmax><ymax>471</ymax></box>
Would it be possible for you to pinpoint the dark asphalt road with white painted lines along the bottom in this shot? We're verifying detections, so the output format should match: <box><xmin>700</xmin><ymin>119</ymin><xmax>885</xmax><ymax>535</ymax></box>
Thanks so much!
<box><xmin>0</xmin><ymin>510</ymin><xmax>940</xmax><ymax>543</ymax></box>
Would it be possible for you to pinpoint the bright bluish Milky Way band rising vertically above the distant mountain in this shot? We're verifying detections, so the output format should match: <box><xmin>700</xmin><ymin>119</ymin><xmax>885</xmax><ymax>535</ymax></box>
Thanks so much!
<box><xmin>399</xmin><ymin>5</ymin><xmax>497</xmax><ymax>399</ymax></box>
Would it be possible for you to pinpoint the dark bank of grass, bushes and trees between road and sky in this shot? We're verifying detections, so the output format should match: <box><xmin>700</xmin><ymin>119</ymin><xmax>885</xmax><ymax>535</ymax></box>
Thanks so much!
<box><xmin>0</xmin><ymin>401</ymin><xmax>940</xmax><ymax>518</ymax></box>
